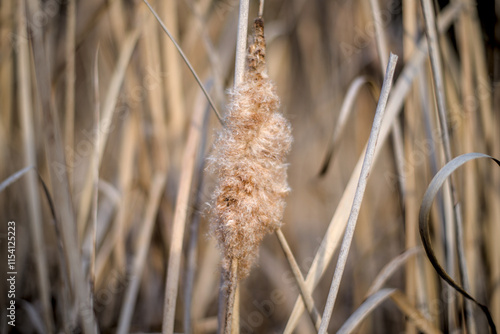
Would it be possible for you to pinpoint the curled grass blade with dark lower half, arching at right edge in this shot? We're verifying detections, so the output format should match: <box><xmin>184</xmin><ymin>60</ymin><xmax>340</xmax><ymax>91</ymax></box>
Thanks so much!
<box><xmin>418</xmin><ymin>153</ymin><xmax>500</xmax><ymax>333</ymax></box>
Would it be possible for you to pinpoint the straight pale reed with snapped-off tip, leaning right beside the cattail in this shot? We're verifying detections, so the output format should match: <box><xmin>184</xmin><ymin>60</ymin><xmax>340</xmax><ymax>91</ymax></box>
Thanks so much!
<box><xmin>319</xmin><ymin>53</ymin><xmax>398</xmax><ymax>334</ymax></box>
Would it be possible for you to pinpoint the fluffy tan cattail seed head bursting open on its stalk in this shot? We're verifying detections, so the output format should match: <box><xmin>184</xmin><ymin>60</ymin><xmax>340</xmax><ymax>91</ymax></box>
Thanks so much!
<box><xmin>209</xmin><ymin>18</ymin><xmax>292</xmax><ymax>280</ymax></box>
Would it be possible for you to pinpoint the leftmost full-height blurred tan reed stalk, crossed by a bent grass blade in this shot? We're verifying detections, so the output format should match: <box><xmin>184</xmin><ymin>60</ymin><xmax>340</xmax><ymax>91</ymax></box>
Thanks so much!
<box><xmin>16</xmin><ymin>0</ymin><xmax>54</xmax><ymax>333</ymax></box>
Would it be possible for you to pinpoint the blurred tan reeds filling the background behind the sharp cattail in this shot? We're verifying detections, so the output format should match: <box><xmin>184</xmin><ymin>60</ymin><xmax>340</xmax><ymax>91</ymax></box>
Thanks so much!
<box><xmin>0</xmin><ymin>0</ymin><xmax>500</xmax><ymax>333</ymax></box>
